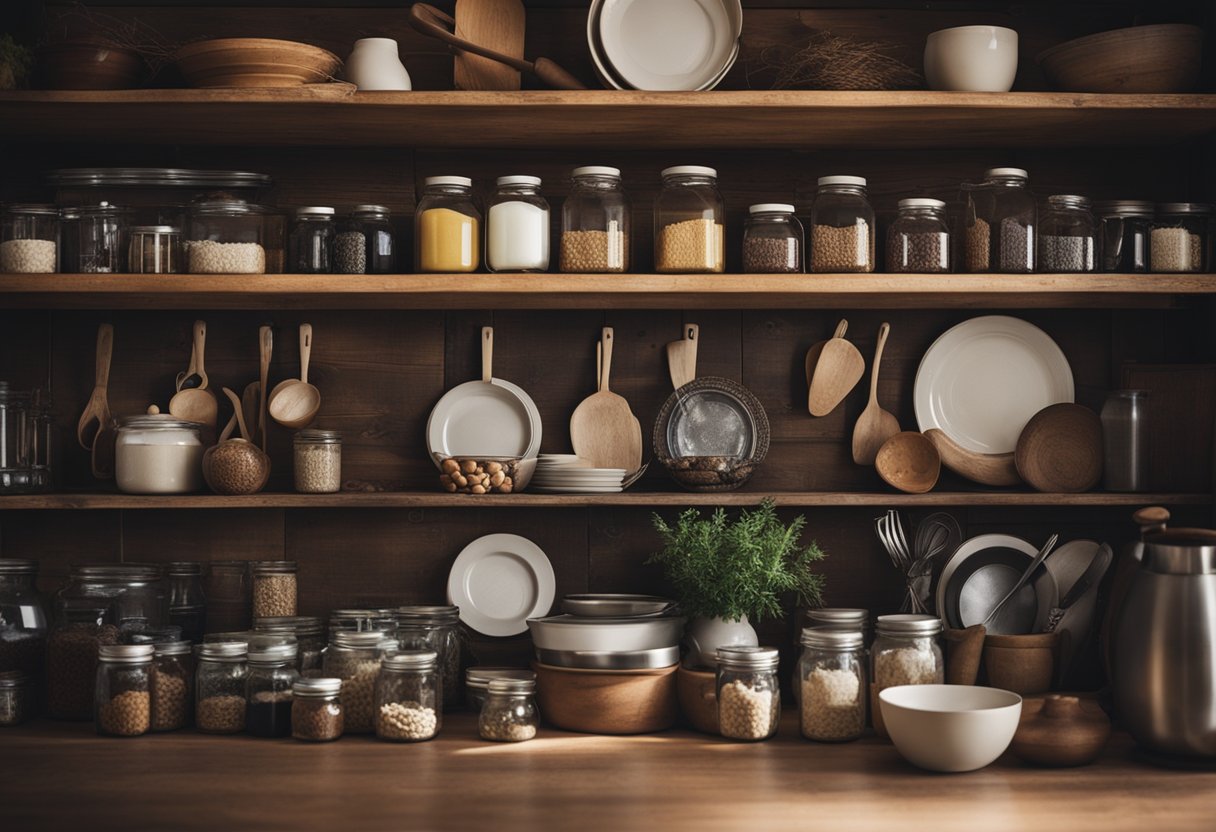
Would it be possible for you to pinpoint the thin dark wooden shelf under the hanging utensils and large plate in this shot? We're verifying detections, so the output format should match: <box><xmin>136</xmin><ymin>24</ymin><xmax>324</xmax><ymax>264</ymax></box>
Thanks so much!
<box><xmin>0</xmin><ymin>490</ymin><xmax>1196</xmax><ymax>511</ymax></box>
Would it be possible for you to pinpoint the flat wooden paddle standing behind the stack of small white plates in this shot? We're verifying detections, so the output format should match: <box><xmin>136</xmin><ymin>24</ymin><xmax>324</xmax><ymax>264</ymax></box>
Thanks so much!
<box><xmin>570</xmin><ymin>326</ymin><xmax>642</xmax><ymax>471</ymax></box>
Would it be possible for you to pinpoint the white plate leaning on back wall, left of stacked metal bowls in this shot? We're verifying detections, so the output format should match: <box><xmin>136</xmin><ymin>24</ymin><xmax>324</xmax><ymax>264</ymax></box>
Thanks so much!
<box><xmin>447</xmin><ymin>532</ymin><xmax>557</xmax><ymax>636</ymax></box>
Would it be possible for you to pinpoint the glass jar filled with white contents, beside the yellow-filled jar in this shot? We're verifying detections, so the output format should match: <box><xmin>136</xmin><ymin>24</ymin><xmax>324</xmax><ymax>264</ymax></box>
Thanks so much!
<box><xmin>485</xmin><ymin>176</ymin><xmax>550</xmax><ymax>271</ymax></box>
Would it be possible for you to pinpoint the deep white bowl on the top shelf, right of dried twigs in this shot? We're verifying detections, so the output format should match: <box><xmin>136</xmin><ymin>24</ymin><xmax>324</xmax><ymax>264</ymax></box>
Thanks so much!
<box><xmin>924</xmin><ymin>26</ymin><xmax>1018</xmax><ymax>92</ymax></box>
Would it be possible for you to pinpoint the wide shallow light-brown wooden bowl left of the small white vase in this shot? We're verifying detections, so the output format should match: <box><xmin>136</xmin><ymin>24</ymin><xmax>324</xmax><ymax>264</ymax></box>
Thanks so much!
<box><xmin>174</xmin><ymin>38</ymin><xmax>342</xmax><ymax>89</ymax></box>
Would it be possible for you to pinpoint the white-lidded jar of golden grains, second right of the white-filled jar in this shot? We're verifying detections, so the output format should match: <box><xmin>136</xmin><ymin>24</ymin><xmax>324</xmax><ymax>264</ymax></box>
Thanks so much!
<box><xmin>654</xmin><ymin>164</ymin><xmax>726</xmax><ymax>274</ymax></box>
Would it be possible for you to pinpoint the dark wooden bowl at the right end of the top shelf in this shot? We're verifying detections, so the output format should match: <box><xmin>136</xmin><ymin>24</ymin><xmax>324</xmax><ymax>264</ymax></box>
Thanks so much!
<box><xmin>1035</xmin><ymin>23</ymin><xmax>1204</xmax><ymax>92</ymax></box>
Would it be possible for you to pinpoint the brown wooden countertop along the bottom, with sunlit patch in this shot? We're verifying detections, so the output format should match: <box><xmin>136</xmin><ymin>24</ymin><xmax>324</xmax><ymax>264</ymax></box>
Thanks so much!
<box><xmin>0</xmin><ymin>712</ymin><xmax>1216</xmax><ymax>832</ymax></box>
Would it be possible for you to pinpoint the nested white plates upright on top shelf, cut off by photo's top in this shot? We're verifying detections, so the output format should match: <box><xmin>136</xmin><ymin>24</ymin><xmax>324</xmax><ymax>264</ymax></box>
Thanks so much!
<box><xmin>599</xmin><ymin>0</ymin><xmax>741</xmax><ymax>90</ymax></box>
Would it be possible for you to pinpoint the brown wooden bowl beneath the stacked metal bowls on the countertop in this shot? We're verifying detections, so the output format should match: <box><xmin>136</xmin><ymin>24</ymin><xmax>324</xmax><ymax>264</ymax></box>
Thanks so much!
<box><xmin>533</xmin><ymin>663</ymin><xmax>679</xmax><ymax>733</ymax></box>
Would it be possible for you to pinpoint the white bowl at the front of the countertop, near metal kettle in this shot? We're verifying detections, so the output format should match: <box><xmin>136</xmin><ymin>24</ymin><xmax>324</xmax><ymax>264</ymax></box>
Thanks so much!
<box><xmin>878</xmin><ymin>685</ymin><xmax>1021</xmax><ymax>771</ymax></box>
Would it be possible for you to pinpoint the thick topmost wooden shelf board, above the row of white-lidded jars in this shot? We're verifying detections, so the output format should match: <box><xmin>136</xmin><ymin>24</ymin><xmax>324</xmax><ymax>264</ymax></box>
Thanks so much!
<box><xmin>0</xmin><ymin>91</ymin><xmax>1216</xmax><ymax>148</ymax></box>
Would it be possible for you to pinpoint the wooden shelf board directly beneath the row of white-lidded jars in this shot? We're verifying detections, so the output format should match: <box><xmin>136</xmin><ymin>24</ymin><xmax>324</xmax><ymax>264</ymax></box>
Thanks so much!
<box><xmin>0</xmin><ymin>274</ymin><xmax>1216</xmax><ymax>309</ymax></box>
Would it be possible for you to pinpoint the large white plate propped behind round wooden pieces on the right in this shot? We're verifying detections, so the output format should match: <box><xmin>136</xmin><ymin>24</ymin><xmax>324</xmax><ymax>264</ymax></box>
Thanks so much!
<box><xmin>913</xmin><ymin>315</ymin><xmax>1074</xmax><ymax>454</ymax></box>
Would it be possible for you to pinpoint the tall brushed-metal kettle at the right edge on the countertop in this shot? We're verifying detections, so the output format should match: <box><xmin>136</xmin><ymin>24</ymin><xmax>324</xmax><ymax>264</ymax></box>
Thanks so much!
<box><xmin>1109</xmin><ymin>508</ymin><xmax>1216</xmax><ymax>758</ymax></box>
